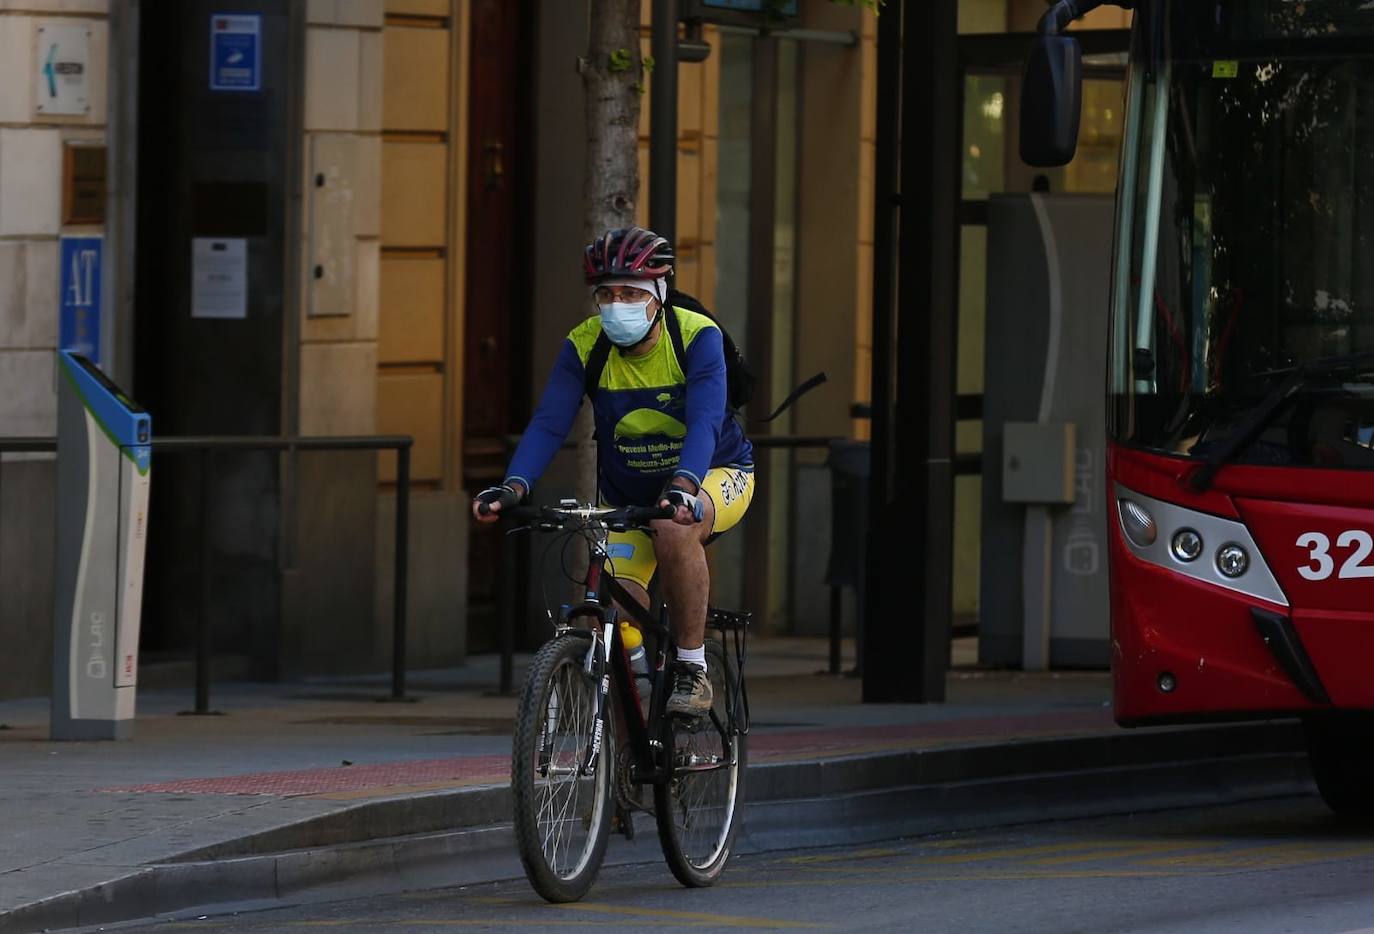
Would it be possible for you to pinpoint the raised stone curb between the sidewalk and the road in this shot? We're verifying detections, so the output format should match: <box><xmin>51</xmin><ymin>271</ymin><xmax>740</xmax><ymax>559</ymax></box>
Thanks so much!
<box><xmin>0</xmin><ymin>721</ymin><xmax>1312</xmax><ymax>934</ymax></box>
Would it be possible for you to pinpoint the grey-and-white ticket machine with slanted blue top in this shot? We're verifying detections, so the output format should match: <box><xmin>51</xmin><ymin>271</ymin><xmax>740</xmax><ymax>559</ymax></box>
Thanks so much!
<box><xmin>51</xmin><ymin>350</ymin><xmax>153</xmax><ymax>739</ymax></box>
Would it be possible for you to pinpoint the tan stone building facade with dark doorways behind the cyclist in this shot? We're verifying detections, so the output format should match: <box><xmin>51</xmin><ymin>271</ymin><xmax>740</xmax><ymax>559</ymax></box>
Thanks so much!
<box><xmin>0</xmin><ymin>0</ymin><xmax>1128</xmax><ymax>695</ymax></box>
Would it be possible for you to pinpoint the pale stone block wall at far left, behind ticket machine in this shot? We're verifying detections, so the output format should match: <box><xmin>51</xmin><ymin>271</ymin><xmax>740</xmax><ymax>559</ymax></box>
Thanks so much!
<box><xmin>0</xmin><ymin>0</ymin><xmax>113</xmax><ymax>696</ymax></box>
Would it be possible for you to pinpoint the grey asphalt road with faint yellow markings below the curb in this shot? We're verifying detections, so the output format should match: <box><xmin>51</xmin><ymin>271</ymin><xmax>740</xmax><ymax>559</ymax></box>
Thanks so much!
<box><xmin>104</xmin><ymin>798</ymin><xmax>1374</xmax><ymax>934</ymax></box>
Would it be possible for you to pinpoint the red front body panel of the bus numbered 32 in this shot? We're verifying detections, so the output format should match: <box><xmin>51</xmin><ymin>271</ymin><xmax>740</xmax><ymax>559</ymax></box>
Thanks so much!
<box><xmin>1107</xmin><ymin>446</ymin><xmax>1374</xmax><ymax>725</ymax></box>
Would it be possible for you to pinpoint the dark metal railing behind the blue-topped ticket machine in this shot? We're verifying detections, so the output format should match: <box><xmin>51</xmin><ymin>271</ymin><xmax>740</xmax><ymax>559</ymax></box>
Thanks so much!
<box><xmin>0</xmin><ymin>434</ymin><xmax>415</xmax><ymax>714</ymax></box>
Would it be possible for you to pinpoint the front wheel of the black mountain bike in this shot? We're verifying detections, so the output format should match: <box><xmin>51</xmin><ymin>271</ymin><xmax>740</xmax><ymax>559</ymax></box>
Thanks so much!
<box><xmin>511</xmin><ymin>636</ymin><xmax>616</xmax><ymax>902</ymax></box>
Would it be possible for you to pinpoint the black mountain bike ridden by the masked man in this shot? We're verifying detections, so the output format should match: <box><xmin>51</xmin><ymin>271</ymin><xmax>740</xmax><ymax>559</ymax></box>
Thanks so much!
<box><xmin>489</xmin><ymin>500</ymin><xmax>750</xmax><ymax>902</ymax></box>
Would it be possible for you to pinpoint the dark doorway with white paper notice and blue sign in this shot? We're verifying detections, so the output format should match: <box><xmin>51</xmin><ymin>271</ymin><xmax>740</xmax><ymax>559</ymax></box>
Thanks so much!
<box><xmin>133</xmin><ymin>0</ymin><xmax>298</xmax><ymax>679</ymax></box>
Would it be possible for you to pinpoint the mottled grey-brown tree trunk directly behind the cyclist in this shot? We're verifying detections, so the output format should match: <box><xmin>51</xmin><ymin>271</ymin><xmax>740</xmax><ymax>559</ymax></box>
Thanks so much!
<box><xmin>574</xmin><ymin>0</ymin><xmax>644</xmax><ymax>499</ymax></box>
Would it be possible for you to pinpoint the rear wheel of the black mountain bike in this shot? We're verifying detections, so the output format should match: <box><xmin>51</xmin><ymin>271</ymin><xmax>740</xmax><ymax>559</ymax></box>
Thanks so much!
<box><xmin>654</xmin><ymin>639</ymin><xmax>747</xmax><ymax>889</ymax></box>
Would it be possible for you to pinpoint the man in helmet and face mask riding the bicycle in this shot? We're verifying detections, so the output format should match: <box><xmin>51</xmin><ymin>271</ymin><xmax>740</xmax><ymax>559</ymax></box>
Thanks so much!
<box><xmin>473</xmin><ymin>227</ymin><xmax>754</xmax><ymax>716</ymax></box>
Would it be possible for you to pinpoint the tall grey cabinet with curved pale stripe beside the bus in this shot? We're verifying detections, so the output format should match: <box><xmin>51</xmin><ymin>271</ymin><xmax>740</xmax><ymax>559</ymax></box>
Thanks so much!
<box><xmin>978</xmin><ymin>192</ymin><xmax>1113</xmax><ymax>670</ymax></box>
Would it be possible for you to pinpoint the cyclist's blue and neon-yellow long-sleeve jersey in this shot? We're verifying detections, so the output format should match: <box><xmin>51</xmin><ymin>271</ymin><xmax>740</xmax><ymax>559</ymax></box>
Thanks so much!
<box><xmin>507</xmin><ymin>309</ymin><xmax>753</xmax><ymax>505</ymax></box>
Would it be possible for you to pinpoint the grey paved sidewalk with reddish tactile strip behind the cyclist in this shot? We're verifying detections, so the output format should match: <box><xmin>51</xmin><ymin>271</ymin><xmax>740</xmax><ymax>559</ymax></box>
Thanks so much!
<box><xmin>0</xmin><ymin>639</ymin><xmax>1297</xmax><ymax>930</ymax></box>
